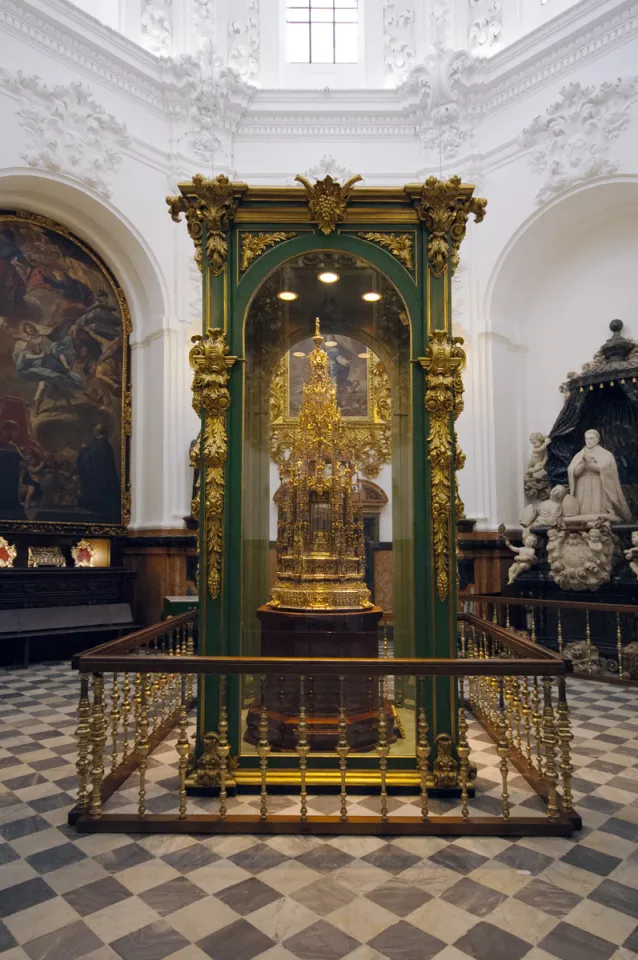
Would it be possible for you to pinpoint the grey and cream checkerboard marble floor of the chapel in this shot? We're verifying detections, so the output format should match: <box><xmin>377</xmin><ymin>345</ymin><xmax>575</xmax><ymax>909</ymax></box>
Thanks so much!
<box><xmin>0</xmin><ymin>664</ymin><xmax>638</xmax><ymax>960</ymax></box>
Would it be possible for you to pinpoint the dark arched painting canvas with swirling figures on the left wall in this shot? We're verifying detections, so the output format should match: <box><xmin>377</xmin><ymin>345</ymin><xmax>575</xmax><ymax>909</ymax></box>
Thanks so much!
<box><xmin>0</xmin><ymin>212</ymin><xmax>127</xmax><ymax>523</ymax></box>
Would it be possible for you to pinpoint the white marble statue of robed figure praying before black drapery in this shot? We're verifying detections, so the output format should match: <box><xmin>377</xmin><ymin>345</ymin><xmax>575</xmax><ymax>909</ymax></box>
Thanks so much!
<box><xmin>568</xmin><ymin>430</ymin><xmax>631</xmax><ymax>523</ymax></box>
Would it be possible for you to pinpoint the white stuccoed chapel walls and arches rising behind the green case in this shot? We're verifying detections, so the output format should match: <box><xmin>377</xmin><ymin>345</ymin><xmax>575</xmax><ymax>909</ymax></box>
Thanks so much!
<box><xmin>0</xmin><ymin>0</ymin><xmax>638</xmax><ymax>530</ymax></box>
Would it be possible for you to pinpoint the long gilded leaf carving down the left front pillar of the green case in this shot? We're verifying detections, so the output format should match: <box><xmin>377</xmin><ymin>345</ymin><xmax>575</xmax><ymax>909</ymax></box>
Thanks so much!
<box><xmin>188</xmin><ymin>327</ymin><xmax>236</xmax><ymax>599</ymax></box>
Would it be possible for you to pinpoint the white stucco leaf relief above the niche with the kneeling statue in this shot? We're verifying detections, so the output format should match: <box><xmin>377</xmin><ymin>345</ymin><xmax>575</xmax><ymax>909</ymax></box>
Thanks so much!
<box><xmin>519</xmin><ymin>77</ymin><xmax>638</xmax><ymax>204</ymax></box>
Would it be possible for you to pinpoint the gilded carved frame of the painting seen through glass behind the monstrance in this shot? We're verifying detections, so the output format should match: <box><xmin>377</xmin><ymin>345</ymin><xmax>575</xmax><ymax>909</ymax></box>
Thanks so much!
<box><xmin>270</xmin><ymin>347</ymin><xmax>392</xmax><ymax>480</ymax></box>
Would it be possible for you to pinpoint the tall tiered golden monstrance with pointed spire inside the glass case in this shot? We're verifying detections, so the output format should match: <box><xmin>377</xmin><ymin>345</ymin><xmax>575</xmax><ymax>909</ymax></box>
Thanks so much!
<box><xmin>269</xmin><ymin>319</ymin><xmax>372</xmax><ymax>610</ymax></box>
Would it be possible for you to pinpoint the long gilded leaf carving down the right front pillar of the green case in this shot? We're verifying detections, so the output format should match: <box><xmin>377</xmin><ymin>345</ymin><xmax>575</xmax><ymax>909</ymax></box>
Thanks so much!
<box><xmin>419</xmin><ymin>330</ymin><xmax>465</xmax><ymax>600</ymax></box>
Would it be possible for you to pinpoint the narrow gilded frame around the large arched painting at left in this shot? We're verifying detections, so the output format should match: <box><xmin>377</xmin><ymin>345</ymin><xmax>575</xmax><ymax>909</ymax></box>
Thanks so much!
<box><xmin>0</xmin><ymin>209</ymin><xmax>133</xmax><ymax>536</ymax></box>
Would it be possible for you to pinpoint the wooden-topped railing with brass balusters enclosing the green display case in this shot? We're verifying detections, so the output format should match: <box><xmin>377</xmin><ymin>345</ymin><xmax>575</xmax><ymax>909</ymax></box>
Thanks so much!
<box><xmin>69</xmin><ymin>612</ymin><xmax>580</xmax><ymax>836</ymax></box>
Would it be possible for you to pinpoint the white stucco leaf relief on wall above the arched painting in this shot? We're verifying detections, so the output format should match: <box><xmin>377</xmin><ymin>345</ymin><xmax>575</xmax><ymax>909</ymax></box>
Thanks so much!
<box><xmin>0</xmin><ymin>68</ymin><xmax>130</xmax><ymax>197</ymax></box>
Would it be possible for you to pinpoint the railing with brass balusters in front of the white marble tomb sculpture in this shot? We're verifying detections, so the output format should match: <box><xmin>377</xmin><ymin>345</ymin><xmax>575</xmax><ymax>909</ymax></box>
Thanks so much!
<box><xmin>461</xmin><ymin>594</ymin><xmax>638</xmax><ymax>682</ymax></box>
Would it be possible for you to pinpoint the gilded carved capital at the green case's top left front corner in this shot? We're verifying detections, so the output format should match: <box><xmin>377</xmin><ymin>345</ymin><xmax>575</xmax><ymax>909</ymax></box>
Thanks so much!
<box><xmin>166</xmin><ymin>173</ymin><xmax>236</xmax><ymax>276</ymax></box>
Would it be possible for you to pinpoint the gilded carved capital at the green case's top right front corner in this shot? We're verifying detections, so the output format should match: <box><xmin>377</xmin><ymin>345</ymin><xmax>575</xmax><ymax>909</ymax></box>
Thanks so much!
<box><xmin>417</xmin><ymin>176</ymin><xmax>487</xmax><ymax>277</ymax></box>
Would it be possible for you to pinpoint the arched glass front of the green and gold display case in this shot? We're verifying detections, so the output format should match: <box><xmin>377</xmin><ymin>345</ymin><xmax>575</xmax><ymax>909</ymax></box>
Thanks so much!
<box><xmin>240</xmin><ymin>252</ymin><xmax>415</xmax><ymax>757</ymax></box>
